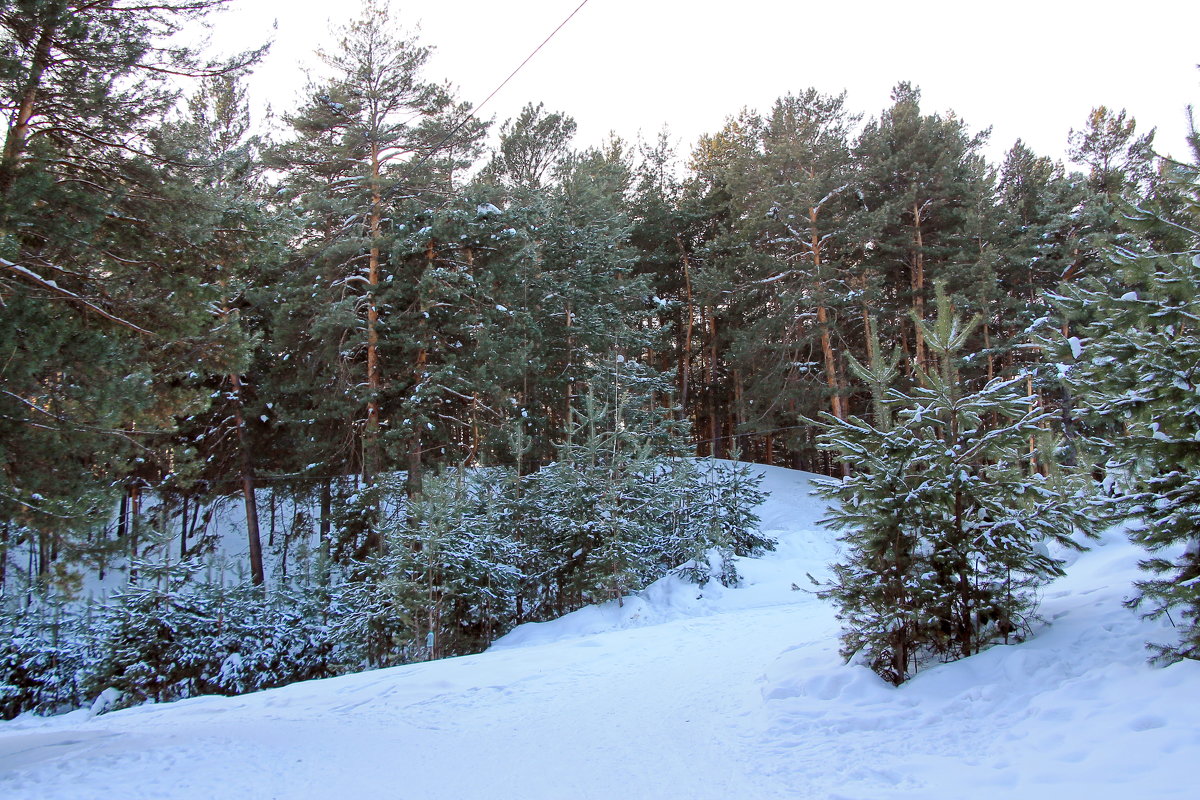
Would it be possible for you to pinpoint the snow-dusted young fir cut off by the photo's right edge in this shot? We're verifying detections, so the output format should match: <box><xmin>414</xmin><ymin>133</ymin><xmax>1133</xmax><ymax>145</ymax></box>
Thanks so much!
<box><xmin>1055</xmin><ymin>115</ymin><xmax>1200</xmax><ymax>658</ymax></box>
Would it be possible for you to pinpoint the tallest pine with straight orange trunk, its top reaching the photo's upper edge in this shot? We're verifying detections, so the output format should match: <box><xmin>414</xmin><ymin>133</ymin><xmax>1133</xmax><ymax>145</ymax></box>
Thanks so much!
<box><xmin>276</xmin><ymin>0</ymin><xmax>482</xmax><ymax>501</ymax></box>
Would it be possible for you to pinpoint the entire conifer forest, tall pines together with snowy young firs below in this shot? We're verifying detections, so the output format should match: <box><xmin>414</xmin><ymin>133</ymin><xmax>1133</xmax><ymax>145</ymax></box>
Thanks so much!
<box><xmin>0</xmin><ymin>0</ymin><xmax>1200</xmax><ymax>717</ymax></box>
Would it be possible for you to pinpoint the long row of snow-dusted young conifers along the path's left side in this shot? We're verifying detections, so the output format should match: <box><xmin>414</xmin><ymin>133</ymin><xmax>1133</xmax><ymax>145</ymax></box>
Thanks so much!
<box><xmin>0</xmin><ymin>395</ymin><xmax>773</xmax><ymax>716</ymax></box>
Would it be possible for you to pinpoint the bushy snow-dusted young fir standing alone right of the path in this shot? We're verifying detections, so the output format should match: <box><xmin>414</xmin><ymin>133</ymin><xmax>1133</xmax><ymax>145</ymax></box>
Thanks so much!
<box><xmin>820</xmin><ymin>285</ymin><xmax>1091</xmax><ymax>684</ymax></box>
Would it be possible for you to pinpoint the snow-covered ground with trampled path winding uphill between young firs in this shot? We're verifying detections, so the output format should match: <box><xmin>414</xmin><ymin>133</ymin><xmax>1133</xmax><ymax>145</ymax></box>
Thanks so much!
<box><xmin>0</xmin><ymin>469</ymin><xmax>1200</xmax><ymax>800</ymax></box>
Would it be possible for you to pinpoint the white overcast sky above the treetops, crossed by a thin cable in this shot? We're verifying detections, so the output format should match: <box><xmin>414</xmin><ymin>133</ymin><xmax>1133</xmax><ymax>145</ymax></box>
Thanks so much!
<box><xmin>214</xmin><ymin>0</ymin><xmax>1200</xmax><ymax>169</ymax></box>
